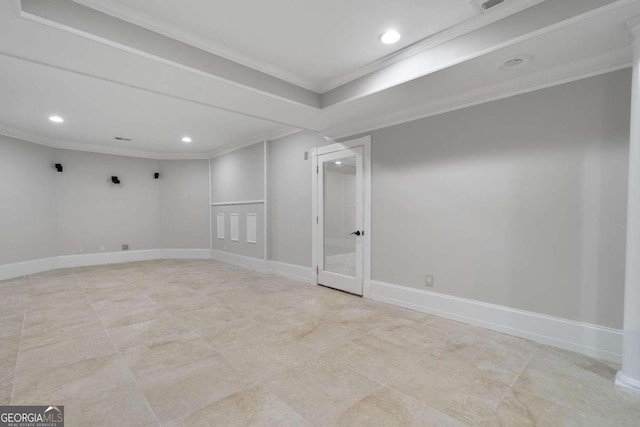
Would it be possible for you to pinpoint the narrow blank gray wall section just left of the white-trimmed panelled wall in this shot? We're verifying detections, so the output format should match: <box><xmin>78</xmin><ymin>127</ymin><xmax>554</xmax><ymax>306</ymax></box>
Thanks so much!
<box><xmin>159</xmin><ymin>160</ymin><xmax>209</xmax><ymax>249</ymax></box>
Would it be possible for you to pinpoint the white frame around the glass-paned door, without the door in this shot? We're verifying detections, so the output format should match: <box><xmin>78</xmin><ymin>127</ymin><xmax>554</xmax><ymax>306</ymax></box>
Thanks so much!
<box><xmin>311</xmin><ymin>135</ymin><xmax>371</xmax><ymax>298</ymax></box>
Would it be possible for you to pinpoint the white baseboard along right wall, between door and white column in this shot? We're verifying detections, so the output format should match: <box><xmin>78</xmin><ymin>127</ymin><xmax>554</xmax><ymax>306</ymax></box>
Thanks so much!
<box><xmin>371</xmin><ymin>281</ymin><xmax>622</xmax><ymax>363</ymax></box>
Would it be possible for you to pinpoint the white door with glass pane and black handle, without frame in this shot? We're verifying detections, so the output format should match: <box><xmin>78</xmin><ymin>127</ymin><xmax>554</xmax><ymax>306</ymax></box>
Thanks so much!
<box><xmin>316</xmin><ymin>146</ymin><xmax>368</xmax><ymax>295</ymax></box>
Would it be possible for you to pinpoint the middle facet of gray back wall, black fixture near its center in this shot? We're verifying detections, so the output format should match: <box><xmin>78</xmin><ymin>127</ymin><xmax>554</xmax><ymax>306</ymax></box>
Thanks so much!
<box><xmin>57</xmin><ymin>150</ymin><xmax>160</xmax><ymax>255</ymax></box>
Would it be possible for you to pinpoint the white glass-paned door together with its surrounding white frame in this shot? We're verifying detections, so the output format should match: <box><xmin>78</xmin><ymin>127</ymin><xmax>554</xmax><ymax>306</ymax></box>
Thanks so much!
<box><xmin>311</xmin><ymin>136</ymin><xmax>371</xmax><ymax>297</ymax></box>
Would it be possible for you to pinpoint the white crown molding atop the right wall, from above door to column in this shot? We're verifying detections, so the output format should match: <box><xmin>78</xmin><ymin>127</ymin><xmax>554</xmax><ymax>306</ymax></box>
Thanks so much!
<box><xmin>322</xmin><ymin>47</ymin><xmax>631</xmax><ymax>139</ymax></box>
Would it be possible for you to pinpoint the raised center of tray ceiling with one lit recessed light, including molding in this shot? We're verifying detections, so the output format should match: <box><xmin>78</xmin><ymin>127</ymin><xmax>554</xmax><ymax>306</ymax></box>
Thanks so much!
<box><xmin>76</xmin><ymin>0</ymin><xmax>478</xmax><ymax>90</ymax></box>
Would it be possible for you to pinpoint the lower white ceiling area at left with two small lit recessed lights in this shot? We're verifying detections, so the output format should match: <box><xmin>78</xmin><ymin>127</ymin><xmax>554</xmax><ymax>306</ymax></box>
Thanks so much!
<box><xmin>0</xmin><ymin>56</ymin><xmax>288</xmax><ymax>157</ymax></box>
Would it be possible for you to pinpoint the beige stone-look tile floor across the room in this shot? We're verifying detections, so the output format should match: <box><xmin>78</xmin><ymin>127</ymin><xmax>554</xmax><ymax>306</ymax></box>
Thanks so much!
<box><xmin>0</xmin><ymin>260</ymin><xmax>640</xmax><ymax>427</ymax></box>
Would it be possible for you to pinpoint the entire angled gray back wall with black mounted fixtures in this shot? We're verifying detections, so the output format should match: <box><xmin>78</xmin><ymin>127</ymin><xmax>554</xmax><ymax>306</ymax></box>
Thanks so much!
<box><xmin>0</xmin><ymin>139</ymin><xmax>209</xmax><ymax>265</ymax></box>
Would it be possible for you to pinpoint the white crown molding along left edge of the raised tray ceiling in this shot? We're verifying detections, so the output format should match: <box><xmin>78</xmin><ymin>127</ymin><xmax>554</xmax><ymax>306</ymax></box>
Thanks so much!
<box><xmin>72</xmin><ymin>0</ymin><xmax>319</xmax><ymax>92</ymax></box>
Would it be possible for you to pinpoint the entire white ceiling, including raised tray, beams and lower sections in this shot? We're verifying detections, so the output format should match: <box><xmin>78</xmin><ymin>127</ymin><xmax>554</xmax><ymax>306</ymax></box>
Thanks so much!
<box><xmin>0</xmin><ymin>0</ymin><xmax>640</xmax><ymax>158</ymax></box>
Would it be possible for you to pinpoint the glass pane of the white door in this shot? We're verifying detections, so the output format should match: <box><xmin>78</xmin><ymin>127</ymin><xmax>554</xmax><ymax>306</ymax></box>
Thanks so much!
<box><xmin>323</xmin><ymin>155</ymin><xmax>357</xmax><ymax>277</ymax></box>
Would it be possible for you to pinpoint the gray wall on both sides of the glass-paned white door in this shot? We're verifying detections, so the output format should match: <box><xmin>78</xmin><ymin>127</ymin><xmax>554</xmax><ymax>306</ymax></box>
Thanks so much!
<box><xmin>270</xmin><ymin>70</ymin><xmax>631</xmax><ymax>328</ymax></box>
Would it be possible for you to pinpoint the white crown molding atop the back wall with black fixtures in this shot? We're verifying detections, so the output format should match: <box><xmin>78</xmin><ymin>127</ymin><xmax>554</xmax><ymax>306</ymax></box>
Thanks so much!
<box><xmin>0</xmin><ymin>125</ymin><xmax>209</xmax><ymax>160</ymax></box>
